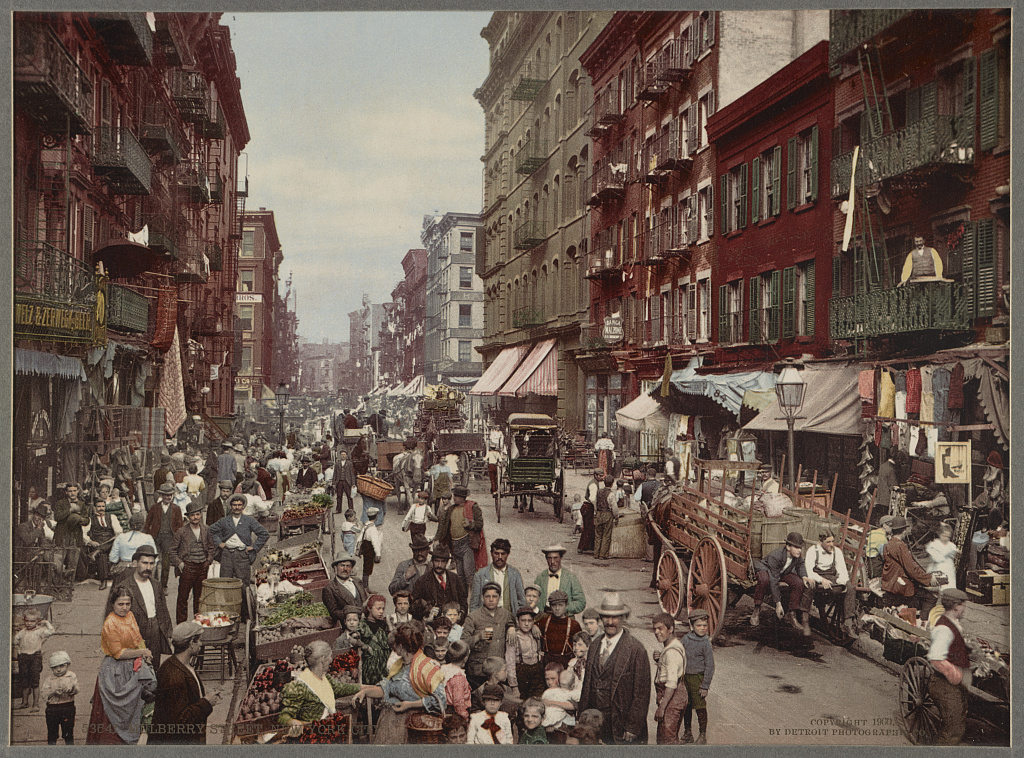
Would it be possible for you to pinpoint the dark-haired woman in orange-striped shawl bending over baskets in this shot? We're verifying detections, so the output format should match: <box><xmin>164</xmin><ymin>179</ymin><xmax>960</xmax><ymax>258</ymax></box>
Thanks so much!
<box><xmin>353</xmin><ymin>624</ymin><xmax>445</xmax><ymax>745</ymax></box>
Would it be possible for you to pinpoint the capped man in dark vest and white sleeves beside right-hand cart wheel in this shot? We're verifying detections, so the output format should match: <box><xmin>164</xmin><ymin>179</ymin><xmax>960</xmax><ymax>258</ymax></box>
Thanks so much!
<box><xmin>928</xmin><ymin>589</ymin><xmax>971</xmax><ymax>745</ymax></box>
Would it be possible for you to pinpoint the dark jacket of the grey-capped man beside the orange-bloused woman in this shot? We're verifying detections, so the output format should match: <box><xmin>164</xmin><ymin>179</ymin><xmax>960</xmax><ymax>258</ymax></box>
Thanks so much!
<box><xmin>146</xmin><ymin>656</ymin><xmax>213</xmax><ymax>745</ymax></box>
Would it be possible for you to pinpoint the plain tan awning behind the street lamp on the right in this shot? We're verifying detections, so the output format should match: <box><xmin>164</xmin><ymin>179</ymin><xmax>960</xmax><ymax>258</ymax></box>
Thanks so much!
<box><xmin>743</xmin><ymin>365</ymin><xmax>862</xmax><ymax>436</ymax></box>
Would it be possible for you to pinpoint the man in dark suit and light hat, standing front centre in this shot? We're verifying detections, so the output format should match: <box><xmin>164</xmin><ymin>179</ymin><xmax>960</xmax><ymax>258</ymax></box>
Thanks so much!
<box><xmin>578</xmin><ymin>592</ymin><xmax>650</xmax><ymax>745</ymax></box>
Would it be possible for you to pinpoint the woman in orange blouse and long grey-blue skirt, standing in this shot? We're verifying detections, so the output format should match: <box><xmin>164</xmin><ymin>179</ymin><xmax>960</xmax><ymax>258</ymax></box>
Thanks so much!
<box><xmin>86</xmin><ymin>587</ymin><xmax>157</xmax><ymax>745</ymax></box>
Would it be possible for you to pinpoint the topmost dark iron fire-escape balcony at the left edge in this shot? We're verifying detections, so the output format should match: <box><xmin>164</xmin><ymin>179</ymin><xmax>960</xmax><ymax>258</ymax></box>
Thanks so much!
<box><xmin>14</xmin><ymin>22</ymin><xmax>93</xmax><ymax>135</ymax></box>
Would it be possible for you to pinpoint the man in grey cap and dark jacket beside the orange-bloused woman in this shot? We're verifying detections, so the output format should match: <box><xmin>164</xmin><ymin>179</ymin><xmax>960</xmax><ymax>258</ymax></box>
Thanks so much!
<box><xmin>146</xmin><ymin>622</ymin><xmax>220</xmax><ymax>745</ymax></box>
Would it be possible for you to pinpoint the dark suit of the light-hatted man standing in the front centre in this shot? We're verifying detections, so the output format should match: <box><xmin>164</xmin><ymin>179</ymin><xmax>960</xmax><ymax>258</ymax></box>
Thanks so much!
<box><xmin>578</xmin><ymin>629</ymin><xmax>650</xmax><ymax>745</ymax></box>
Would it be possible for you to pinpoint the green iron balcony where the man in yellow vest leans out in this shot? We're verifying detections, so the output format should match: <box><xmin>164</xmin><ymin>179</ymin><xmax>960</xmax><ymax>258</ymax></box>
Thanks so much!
<box><xmin>828</xmin><ymin>282</ymin><xmax>971</xmax><ymax>339</ymax></box>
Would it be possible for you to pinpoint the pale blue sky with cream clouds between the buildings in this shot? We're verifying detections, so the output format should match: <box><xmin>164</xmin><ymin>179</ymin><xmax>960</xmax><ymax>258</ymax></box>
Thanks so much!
<box><xmin>221</xmin><ymin>11</ymin><xmax>490</xmax><ymax>342</ymax></box>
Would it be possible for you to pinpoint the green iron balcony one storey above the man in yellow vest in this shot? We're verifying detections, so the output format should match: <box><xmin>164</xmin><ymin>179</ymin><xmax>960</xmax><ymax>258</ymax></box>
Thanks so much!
<box><xmin>831</xmin><ymin>114</ymin><xmax>974</xmax><ymax>198</ymax></box>
